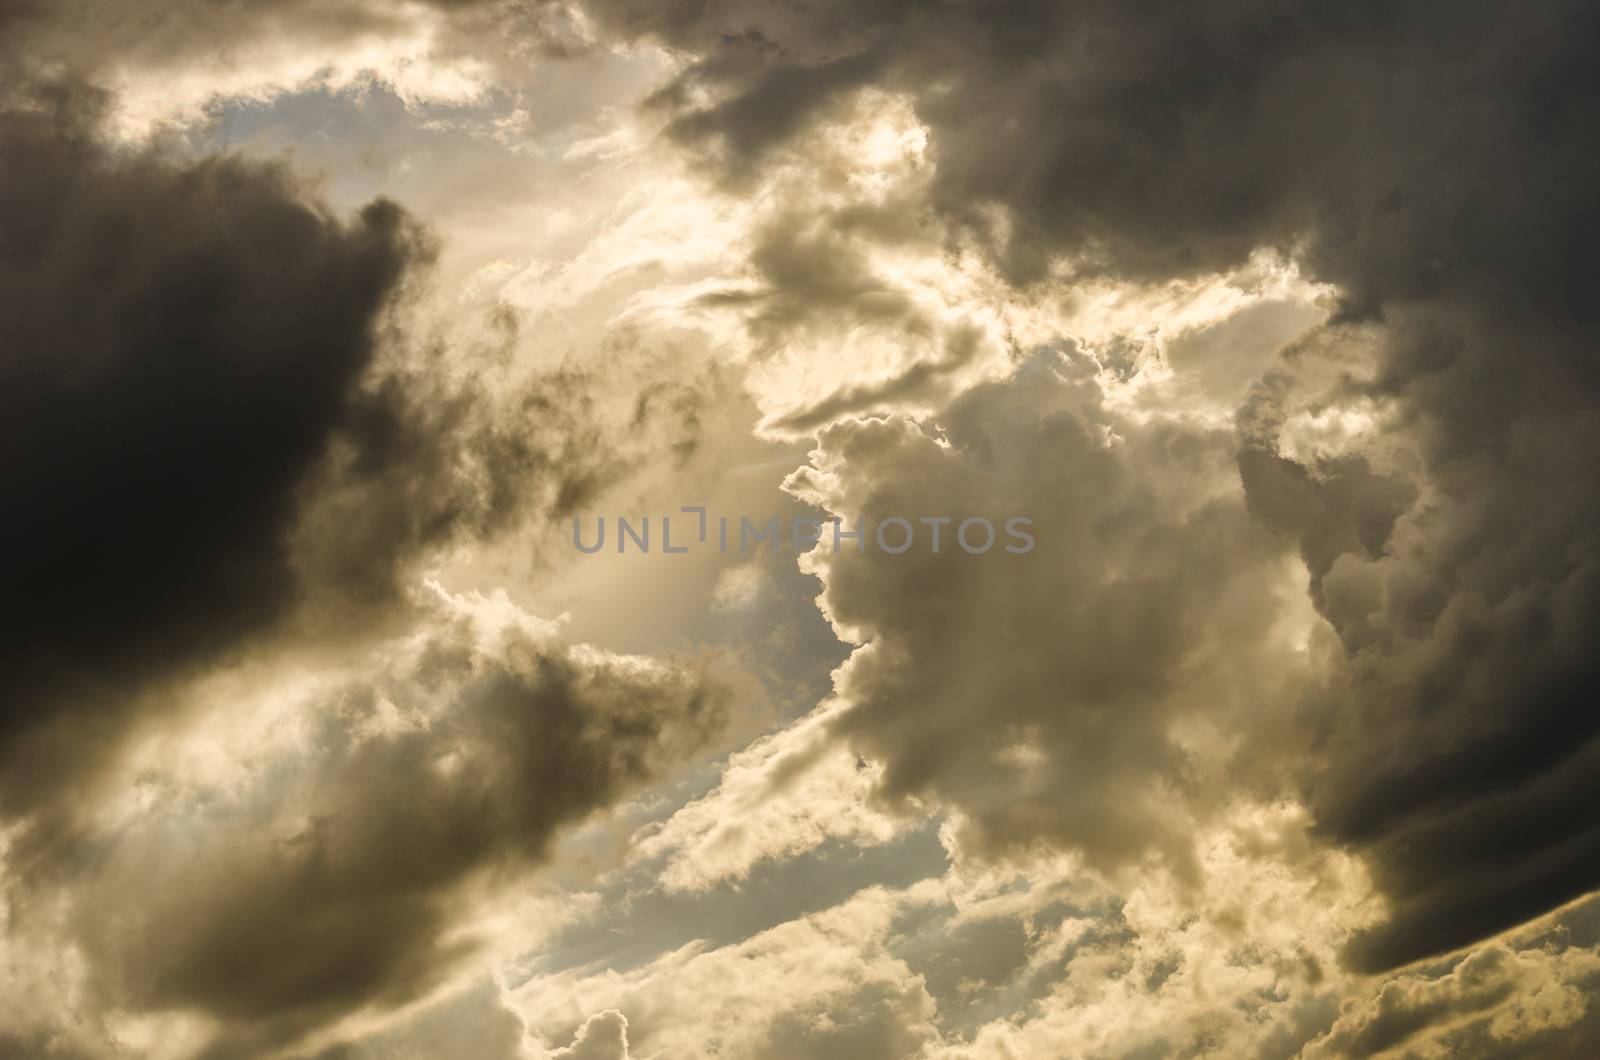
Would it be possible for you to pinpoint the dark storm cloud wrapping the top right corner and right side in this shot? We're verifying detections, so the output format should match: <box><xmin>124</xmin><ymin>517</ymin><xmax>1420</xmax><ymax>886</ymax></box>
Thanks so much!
<box><xmin>572</xmin><ymin>0</ymin><xmax>1600</xmax><ymax>967</ymax></box>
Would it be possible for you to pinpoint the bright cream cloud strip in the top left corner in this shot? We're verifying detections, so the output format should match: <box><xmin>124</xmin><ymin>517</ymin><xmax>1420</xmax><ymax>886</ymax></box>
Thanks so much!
<box><xmin>0</xmin><ymin>0</ymin><xmax>594</xmax><ymax>132</ymax></box>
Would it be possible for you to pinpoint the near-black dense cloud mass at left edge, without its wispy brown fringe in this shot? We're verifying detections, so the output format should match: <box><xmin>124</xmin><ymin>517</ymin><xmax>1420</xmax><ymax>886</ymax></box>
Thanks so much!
<box><xmin>0</xmin><ymin>86</ymin><xmax>429</xmax><ymax>809</ymax></box>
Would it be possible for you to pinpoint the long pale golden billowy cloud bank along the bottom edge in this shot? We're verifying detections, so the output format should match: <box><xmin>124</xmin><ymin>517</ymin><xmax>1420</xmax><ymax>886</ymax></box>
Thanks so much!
<box><xmin>514</xmin><ymin>804</ymin><xmax>1370</xmax><ymax>1060</ymax></box>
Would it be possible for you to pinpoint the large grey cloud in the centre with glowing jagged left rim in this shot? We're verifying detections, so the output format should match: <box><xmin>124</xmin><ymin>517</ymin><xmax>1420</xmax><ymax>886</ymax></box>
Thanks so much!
<box><xmin>795</xmin><ymin>351</ymin><xmax>1294</xmax><ymax>871</ymax></box>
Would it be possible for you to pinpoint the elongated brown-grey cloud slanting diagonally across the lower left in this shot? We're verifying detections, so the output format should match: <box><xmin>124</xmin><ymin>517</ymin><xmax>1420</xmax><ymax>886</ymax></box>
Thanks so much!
<box><xmin>70</xmin><ymin>620</ymin><xmax>726</xmax><ymax>1057</ymax></box>
